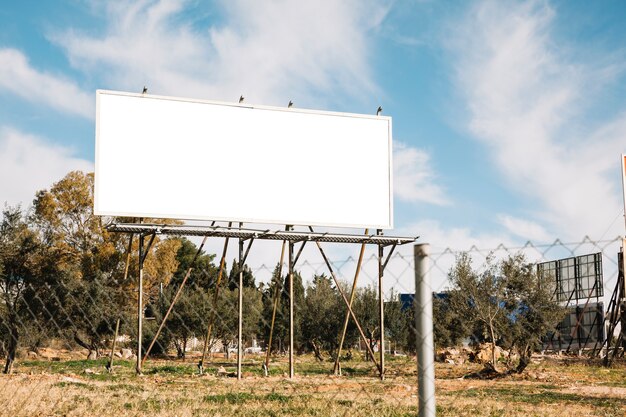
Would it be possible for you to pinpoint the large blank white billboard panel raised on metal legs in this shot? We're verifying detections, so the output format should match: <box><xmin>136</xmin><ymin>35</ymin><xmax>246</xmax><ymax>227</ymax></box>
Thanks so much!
<box><xmin>94</xmin><ymin>90</ymin><xmax>393</xmax><ymax>229</ymax></box>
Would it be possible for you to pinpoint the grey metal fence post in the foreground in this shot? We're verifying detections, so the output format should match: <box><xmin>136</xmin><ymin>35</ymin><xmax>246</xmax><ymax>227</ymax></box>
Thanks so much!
<box><xmin>413</xmin><ymin>243</ymin><xmax>436</xmax><ymax>417</ymax></box>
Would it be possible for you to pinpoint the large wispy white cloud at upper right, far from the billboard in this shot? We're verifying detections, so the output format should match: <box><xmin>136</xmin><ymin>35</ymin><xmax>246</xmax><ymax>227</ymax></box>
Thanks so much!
<box><xmin>454</xmin><ymin>1</ymin><xmax>626</xmax><ymax>239</ymax></box>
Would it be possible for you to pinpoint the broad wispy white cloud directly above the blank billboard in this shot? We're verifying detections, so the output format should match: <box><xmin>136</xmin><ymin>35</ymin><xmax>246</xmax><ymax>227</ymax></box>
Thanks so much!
<box><xmin>52</xmin><ymin>0</ymin><xmax>386</xmax><ymax>105</ymax></box>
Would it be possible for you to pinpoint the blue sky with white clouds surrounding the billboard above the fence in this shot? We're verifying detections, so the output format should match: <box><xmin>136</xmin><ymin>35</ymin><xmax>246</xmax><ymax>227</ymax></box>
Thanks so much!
<box><xmin>0</xmin><ymin>0</ymin><xmax>626</xmax><ymax>256</ymax></box>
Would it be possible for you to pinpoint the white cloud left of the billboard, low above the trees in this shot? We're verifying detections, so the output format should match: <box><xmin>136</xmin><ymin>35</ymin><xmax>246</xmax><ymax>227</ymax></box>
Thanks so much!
<box><xmin>0</xmin><ymin>127</ymin><xmax>93</xmax><ymax>208</ymax></box>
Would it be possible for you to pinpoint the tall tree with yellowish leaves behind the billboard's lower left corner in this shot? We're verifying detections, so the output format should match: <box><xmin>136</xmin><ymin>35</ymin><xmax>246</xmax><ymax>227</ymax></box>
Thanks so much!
<box><xmin>29</xmin><ymin>171</ymin><xmax>180</xmax><ymax>352</ymax></box>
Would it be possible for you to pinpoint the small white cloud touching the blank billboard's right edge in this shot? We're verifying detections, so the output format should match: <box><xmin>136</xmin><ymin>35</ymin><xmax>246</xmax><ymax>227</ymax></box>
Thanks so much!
<box><xmin>393</xmin><ymin>141</ymin><xmax>450</xmax><ymax>205</ymax></box>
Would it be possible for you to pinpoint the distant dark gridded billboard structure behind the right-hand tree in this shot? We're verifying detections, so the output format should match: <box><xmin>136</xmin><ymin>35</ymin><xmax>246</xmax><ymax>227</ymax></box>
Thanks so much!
<box><xmin>537</xmin><ymin>253</ymin><xmax>605</xmax><ymax>351</ymax></box>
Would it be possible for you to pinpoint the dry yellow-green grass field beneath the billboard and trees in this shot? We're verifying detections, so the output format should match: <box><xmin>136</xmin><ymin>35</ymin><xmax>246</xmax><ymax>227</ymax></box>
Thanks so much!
<box><xmin>0</xmin><ymin>356</ymin><xmax>626</xmax><ymax>417</ymax></box>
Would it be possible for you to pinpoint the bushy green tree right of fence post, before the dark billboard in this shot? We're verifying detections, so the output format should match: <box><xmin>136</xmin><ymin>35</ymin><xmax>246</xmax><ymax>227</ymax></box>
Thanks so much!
<box><xmin>450</xmin><ymin>254</ymin><xmax>565</xmax><ymax>372</ymax></box>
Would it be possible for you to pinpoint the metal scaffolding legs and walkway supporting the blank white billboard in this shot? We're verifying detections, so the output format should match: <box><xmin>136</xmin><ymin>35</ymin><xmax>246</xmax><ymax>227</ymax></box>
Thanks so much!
<box><xmin>107</xmin><ymin>222</ymin><xmax>417</xmax><ymax>379</ymax></box>
